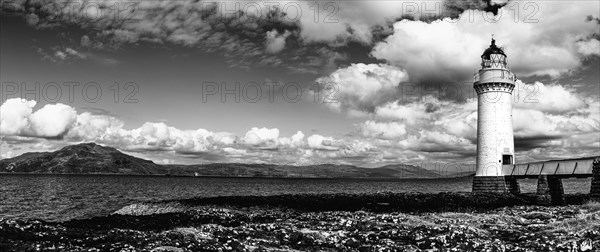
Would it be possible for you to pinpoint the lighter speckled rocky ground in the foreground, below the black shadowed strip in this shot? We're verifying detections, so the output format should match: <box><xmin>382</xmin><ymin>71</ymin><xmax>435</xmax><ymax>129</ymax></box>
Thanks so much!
<box><xmin>0</xmin><ymin>197</ymin><xmax>600</xmax><ymax>251</ymax></box>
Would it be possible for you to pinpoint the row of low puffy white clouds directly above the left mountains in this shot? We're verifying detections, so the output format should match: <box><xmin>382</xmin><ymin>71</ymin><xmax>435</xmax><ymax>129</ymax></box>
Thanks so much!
<box><xmin>0</xmin><ymin>99</ymin><xmax>382</xmax><ymax>164</ymax></box>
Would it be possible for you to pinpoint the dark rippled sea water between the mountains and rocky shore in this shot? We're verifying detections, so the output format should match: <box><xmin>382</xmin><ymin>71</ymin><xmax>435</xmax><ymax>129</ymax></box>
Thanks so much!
<box><xmin>0</xmin><ymin>175</ymin><xmax>590</xmax><ymax>221</ymax></box>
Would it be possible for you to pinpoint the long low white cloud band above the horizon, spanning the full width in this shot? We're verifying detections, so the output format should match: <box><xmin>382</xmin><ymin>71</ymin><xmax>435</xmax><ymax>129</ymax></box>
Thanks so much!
<box><xmin>0</xmin><ymin>82</ymin><xmax>600</xmax><ymax>165</ymax></box>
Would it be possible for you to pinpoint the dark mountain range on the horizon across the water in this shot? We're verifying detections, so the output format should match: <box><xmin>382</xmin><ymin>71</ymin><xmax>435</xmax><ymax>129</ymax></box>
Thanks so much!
<box><xmin>0</xmin><ymin>143</ymin><xmax>468</xmax><ymax>178</ymax></box>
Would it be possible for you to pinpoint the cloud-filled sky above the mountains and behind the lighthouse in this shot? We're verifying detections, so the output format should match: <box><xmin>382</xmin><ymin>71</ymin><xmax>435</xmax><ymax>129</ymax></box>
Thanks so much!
<box><xmin>0</xmin><ymin>0</ymin><xmax>600</xmax><ymax>167</ymax></box>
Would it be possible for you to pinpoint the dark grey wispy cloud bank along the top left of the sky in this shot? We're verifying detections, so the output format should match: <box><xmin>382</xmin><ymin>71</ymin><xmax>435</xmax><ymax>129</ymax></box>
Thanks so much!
<box><xmin>2</xmin><ymin>0</ymin><xmax>510</xmax><ymax>74</ymax></box>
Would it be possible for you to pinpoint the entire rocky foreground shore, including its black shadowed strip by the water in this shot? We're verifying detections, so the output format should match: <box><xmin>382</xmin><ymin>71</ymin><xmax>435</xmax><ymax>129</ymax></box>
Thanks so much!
<box><xmin>0</xmin><ymin>193</ymin><xmax>600</xmax><ymax>251</ymax></box>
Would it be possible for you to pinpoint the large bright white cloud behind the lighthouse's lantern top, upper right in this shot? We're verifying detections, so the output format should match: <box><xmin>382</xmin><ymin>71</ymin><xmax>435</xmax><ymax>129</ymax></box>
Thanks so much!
<box><xmin>371</xmin><ymin>1</ymin><xmax>600</xmax><ymax>83</ymax></box>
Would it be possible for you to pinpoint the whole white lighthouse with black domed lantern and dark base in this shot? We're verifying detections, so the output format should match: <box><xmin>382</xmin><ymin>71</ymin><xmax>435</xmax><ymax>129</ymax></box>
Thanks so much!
<box><xmin>473</xmin><ymin>38</ymin><xmax>516</xmax><ymax>193</ymax></box>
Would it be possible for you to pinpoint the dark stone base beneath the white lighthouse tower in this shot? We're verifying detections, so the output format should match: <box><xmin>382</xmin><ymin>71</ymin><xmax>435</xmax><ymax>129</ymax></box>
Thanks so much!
<box><xmin>472</xmin><ymin>176</ymin><xmax>521</xmax><ymax>194</ymax></box>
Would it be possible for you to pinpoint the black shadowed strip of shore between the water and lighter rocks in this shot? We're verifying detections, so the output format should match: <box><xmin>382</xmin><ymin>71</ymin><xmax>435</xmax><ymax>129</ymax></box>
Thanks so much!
<box><xmin>168</xmin><ymin>192</ymin><xmax>590</xmax><ymax>212</ymax></box>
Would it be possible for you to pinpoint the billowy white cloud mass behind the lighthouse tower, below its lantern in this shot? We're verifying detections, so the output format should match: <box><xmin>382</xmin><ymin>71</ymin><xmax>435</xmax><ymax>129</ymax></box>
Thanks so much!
<box><xmin>309</xmin><ymin>74</ymin><xmax>600</xmax><ymax>162</ymax></box>
